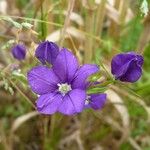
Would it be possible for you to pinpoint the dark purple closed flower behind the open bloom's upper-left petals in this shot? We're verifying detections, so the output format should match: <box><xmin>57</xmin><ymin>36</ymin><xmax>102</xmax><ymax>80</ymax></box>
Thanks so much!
<box><xmin>35</xmin><ymin>41</ymin><xmax>59</xmax><ymax>64</ymax></box>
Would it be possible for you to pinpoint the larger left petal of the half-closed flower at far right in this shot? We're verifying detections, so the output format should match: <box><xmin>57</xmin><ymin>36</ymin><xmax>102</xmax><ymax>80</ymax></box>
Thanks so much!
<box><xmin>111</xmin><ymin>52</ymin><xmax>136</xmax><ymax>78</ymax></box>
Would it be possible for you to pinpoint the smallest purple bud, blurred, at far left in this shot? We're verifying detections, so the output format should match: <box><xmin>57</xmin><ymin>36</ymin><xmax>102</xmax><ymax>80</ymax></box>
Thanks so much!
<box><xmin>11</xmin><ymin>44</ymin><xmax>26</xmax><ymax>60</ymax></box>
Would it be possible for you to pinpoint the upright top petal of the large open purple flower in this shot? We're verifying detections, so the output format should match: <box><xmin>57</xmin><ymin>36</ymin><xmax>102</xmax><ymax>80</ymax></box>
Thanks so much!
<box><xmin>53</xmin><ymin>48</ymin><xmax>78</xmax><ymax>82</ymax></box>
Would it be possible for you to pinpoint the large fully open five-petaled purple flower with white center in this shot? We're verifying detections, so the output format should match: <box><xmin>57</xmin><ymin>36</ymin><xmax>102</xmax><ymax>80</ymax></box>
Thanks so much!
<box><xmin>27</xmin><ymin>48</ymin><xmax>99</xmax><ymax>115</ymax></box>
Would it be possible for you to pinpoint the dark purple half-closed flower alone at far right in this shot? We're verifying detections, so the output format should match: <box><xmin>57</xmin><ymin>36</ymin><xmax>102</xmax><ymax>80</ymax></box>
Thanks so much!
<box><xmin>111</xmin><ymin>52</ymin><xmax>144</xmax><ymax>82</ymax></box>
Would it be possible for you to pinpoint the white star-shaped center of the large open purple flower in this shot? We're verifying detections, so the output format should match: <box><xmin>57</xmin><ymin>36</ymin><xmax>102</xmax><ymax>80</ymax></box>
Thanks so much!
<box><xmin>57</xmin><ymin>83</ymin><xmax>72</xmax><ymax>95</ymax></box>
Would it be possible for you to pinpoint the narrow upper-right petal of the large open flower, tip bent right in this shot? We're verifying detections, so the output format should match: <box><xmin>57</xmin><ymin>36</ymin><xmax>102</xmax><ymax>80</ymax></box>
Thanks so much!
<box><xmin>72</xmin><ymin>64</ymin><xmax>99</xmax><ymax>89</ymax></box>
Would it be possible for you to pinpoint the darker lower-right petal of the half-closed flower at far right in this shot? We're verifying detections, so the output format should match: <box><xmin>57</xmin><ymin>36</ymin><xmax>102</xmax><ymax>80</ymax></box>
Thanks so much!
<box><xmin>119</xmin><ymin>60</ymin><xmax>142</xmax><ymax>82</ymax></box>
